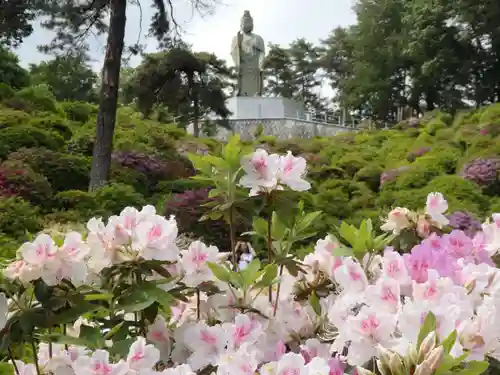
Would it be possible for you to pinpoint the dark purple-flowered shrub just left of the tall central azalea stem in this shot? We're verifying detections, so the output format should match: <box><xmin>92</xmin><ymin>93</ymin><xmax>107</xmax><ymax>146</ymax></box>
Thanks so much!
<box><xmin>164</xmin><ymin>188</ymin><xmax>230</xmax><ymax>249</ymax></box>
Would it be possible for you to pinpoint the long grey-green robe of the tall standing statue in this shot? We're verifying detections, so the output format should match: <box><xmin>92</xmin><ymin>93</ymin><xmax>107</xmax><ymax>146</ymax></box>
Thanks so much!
<box><xmin>231</xmin><ymin>32</ymin><xmax>265</xmax><ymax>96</ymax></box>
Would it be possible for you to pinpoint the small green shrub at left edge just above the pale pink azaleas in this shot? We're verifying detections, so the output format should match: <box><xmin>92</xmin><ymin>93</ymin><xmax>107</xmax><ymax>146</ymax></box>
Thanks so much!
<box><xmin>0</xmin><ymin>197</ymin><xmax>43</xmax><ymax>241</ymax></box>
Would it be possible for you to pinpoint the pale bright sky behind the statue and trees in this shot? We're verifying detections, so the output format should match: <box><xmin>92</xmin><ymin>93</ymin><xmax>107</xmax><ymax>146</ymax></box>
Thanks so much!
<box><xmin>16</xmin><ymin>0</ymin><xmax>355</xmax><ymax>98</ymax></box>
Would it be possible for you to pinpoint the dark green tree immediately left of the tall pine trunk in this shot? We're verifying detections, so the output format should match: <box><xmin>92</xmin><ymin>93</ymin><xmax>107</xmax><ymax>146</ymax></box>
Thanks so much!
<box><xmin>30</xmin><ymin>52</ymin><xmax>97</xmax><ymax>102</ymax></box>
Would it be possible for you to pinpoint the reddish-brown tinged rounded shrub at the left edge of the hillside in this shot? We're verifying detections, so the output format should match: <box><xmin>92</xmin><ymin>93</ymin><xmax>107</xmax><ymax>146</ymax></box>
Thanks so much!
<box><xmin>0</xmin><ymin>160</ymin><xmax>52</xmax><ymax>207</ymax></box>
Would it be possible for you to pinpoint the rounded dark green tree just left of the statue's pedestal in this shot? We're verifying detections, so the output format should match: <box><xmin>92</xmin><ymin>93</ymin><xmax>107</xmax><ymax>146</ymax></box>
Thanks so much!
<box><xmin>125</xmin><ymin>47</ymin><xmax>234</xmax><ymax>136</ymax></box>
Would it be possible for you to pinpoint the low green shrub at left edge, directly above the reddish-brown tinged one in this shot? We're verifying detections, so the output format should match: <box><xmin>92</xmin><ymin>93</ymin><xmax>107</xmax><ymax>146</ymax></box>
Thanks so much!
<box><xmin>0</xmin><ymin>126</ymin><xmax>64</xmax><ymax>159</ymax></box>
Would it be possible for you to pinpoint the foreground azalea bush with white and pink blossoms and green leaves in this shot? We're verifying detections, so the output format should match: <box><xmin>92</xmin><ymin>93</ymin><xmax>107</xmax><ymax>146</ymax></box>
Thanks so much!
<box><xmin>0</xmin><ymin>138</ymin><xmax>500</xmax><ymax>375</ymax></box>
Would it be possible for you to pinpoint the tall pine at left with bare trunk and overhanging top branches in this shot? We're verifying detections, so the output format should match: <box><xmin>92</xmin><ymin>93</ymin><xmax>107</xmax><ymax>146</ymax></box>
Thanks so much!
<box><xmin>43</xmin><ymin>0</ymin><xmax>224</xmax><ymax>191</ymax></box>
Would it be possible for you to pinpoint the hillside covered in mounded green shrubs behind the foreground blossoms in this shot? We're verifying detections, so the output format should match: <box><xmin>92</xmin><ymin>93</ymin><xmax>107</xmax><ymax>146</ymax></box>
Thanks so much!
<box><xmin>0</xmin><ymin>88</ymin><xmax>500</xmax><ymax>256</ymax></box>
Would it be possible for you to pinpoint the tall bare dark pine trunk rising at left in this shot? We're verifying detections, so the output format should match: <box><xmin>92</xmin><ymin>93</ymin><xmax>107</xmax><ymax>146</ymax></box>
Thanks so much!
<box><xmin>89</xmin><ymin>0</ymin><xmax>127</xmax><ymax>191</ymax></box>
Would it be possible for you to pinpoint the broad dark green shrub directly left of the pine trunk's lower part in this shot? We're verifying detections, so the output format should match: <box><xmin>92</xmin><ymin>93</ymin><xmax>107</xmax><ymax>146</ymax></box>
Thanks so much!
<box><xmin>9</xmin><ymin>148</ymin><xmax>90</xmax><ymax>192</ymax></box>
